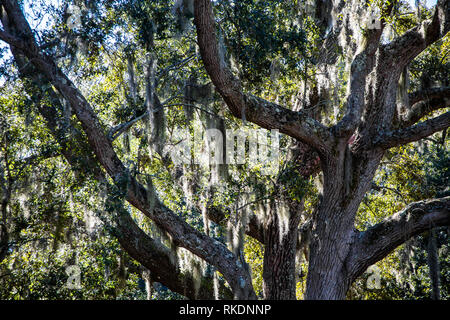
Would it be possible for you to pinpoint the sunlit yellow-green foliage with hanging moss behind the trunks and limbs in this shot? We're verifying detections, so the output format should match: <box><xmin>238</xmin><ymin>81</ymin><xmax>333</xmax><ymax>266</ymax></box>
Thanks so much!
<box><xmin>0</xmin><ymin>0</ymin><xmax>450</xmax><ymax>299</ymax></box>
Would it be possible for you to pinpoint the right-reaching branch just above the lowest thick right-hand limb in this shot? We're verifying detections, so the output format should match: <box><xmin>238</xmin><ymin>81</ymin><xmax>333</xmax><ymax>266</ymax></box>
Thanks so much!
<box><xmin>372</xmin><ymin>111</ymin><xmax>450</xmax><ymax>149</ymax></box>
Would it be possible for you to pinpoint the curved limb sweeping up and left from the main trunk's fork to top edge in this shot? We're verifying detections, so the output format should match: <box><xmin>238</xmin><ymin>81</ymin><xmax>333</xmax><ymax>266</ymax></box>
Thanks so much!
<box><xmin>194</xmin><ymin>0</ymin><xmax>332</xmax><ymax>150</ymax></box>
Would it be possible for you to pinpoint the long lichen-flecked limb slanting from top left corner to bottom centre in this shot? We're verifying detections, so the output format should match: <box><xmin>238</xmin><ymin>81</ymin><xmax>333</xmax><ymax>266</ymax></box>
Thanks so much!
<box><xmin>2</xmin><ymin>0</ymin><xmax>256</xmax><ymax>299</ymax></box>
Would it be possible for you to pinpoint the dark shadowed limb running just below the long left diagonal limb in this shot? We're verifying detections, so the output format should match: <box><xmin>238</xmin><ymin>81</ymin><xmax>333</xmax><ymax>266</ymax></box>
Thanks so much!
<box><xmin>9</xmin><ymin>56</ymin><xmax>232</xmax><ymax>299</ymax></box>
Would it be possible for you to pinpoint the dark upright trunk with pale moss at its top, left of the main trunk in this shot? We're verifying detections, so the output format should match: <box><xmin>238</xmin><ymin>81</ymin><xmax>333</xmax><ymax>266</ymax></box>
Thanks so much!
<box><xmin>263</xmin><ymin>200</ymin><xmax>300</xmax><ymax>300</ymax></box>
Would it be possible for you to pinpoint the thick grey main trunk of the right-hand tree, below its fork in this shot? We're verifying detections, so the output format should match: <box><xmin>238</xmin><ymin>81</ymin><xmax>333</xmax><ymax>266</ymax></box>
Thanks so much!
<box><xmin>305</xmin><ymin>145</ymin><xmax>383</xmax><ymax>300</ymax></box>
